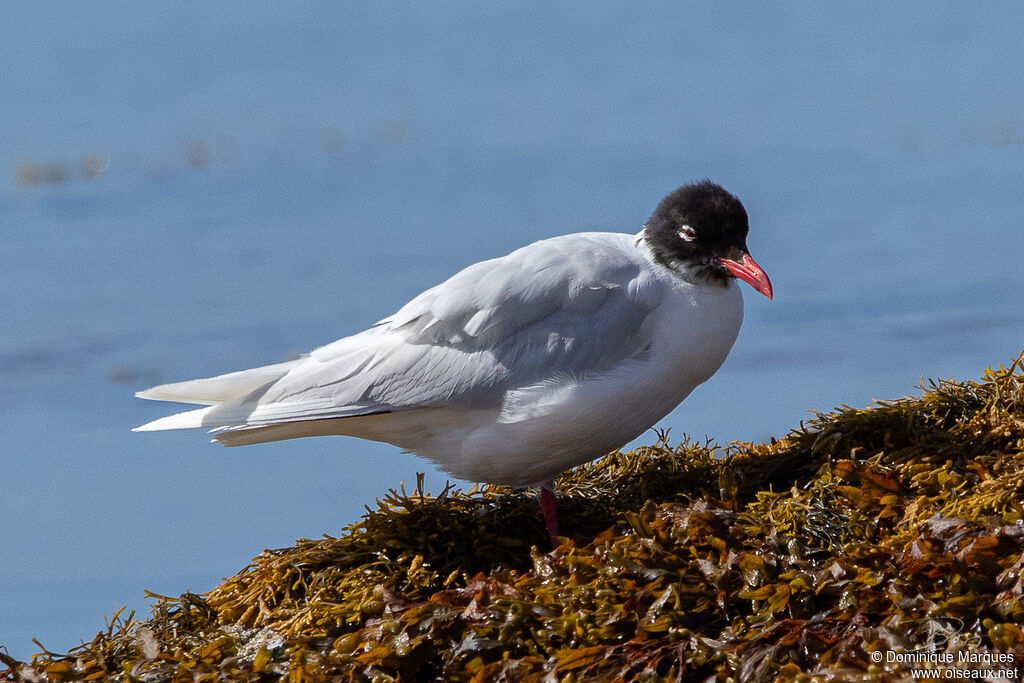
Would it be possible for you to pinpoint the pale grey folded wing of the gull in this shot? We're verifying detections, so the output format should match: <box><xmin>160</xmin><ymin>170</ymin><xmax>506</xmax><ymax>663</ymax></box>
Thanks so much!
<box><xmin>203</xmin><ymin>233</ymin><xmax>656</xmax><ymax>426</ymax></box>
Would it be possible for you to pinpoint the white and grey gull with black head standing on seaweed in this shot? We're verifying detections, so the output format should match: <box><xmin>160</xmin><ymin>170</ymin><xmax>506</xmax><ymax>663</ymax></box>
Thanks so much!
<box><xmin>135</xmin><ymin>179</ymin><xmax>774</xmax><ymax>548</ymax></box>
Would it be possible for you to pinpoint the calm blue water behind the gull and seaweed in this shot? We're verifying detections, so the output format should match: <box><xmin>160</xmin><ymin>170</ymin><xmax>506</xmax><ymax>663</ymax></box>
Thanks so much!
<box><xmin>0</xmin><ymin>2</ymin><xmax>1024</xmax><ymax>657</ymax></box>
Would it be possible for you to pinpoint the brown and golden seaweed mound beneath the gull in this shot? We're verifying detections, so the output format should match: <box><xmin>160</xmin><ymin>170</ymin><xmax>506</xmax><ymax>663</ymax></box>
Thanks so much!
<box><xmin>0</xmin><ymin>353</ymin><xmax>1024</xmax><ymax>682</ymax></box>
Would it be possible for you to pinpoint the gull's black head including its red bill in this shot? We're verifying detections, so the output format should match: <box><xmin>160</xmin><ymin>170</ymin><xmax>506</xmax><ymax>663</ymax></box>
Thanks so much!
<box><xmin>643</xmin><ymin>180</ymin><xmax>772</xmax><ymax>298</ymax></box>
